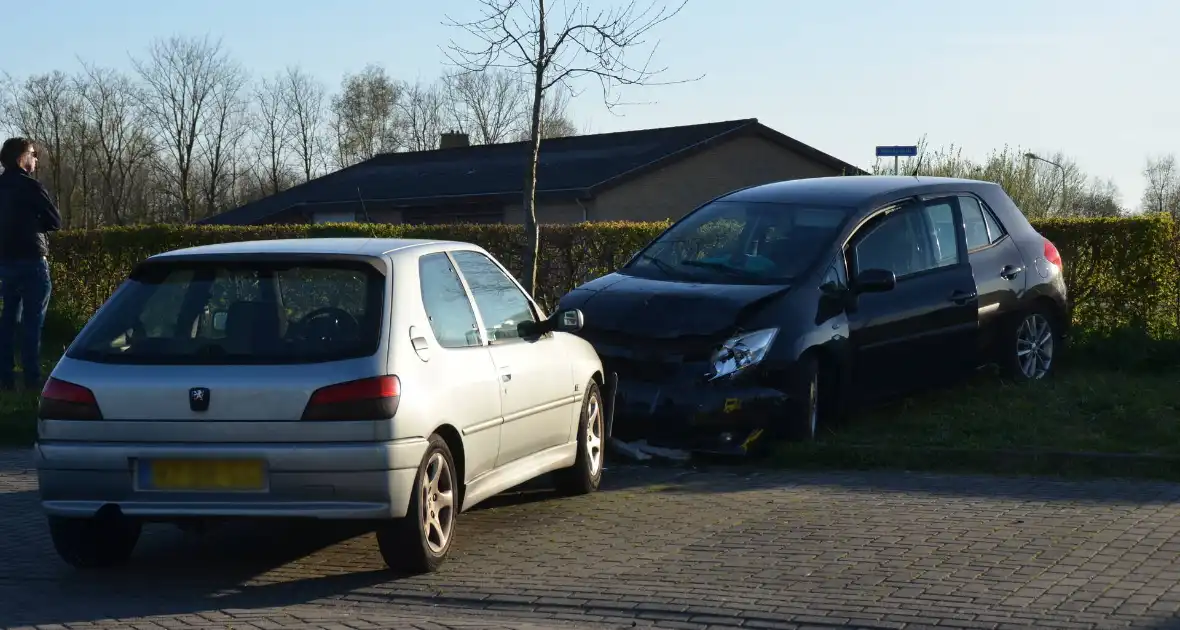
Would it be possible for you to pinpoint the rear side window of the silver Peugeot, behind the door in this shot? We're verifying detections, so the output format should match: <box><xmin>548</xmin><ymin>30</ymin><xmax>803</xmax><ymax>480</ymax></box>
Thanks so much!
<box><xmin>418</xmin><ymin>252</ymin><xmax>480</xmax><ymax>348</ymax></box>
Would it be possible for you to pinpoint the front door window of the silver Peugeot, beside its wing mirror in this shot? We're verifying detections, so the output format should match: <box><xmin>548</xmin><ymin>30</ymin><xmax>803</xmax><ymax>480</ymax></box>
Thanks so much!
<box><xmin>451</xmin><ymin>251</ymin><xmax>537</xmax><ymax>343</ymax></box>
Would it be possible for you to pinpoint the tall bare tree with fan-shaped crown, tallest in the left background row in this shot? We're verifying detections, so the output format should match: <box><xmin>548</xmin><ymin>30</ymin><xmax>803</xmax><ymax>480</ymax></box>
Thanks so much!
<box><xmin>132</xmin><ymin>37</ymin><xmax>238</xmax><ymax>223</ymax></box>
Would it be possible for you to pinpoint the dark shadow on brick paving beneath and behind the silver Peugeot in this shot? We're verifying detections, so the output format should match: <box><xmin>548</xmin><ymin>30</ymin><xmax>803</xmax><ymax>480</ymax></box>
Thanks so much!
<box><xmin>0</xmin><ymin>478</ymin><xmax>627</xmax><ymax>628</ymax></box>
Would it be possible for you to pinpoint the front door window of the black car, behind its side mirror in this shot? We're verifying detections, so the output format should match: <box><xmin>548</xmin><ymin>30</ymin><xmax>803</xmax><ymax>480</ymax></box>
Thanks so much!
<box><xmin>853</xmin><ymin>199</ymin><xmax>959</xmax><ymax>278</ymax></box>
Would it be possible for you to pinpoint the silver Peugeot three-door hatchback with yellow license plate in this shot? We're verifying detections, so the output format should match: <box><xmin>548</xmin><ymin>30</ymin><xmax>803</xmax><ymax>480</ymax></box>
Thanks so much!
<box><xmin>35</xmin><ymin>238</ymin><xmax>607</xmax><ymax>572</ymax></box>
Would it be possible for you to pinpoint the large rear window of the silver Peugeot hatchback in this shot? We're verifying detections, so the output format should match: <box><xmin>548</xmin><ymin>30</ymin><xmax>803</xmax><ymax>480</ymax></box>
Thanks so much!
<box><xmin>68</xmin><ymin>260</ymin><xmax>385</xmax><ymax>365</ymax></box>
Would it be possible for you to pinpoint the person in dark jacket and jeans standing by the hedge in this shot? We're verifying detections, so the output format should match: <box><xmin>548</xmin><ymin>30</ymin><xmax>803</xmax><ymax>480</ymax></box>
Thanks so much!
<box><xmin>0</xmin><ymin>137</ymin><xmax>61</xmax><ymax>389</ymax></box>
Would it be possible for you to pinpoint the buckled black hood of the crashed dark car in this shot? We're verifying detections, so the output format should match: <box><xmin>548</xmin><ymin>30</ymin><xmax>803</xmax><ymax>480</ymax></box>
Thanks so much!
<box><xmin>559</xmin><ymin>273</ymin><xmax>789</xmax><ymax>339</ymax></box>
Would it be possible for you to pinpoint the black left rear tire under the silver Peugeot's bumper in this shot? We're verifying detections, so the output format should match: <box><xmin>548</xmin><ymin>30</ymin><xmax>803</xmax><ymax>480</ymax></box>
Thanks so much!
<box><xmin>48</xmin><ymin>514</ymin><xmax>143</xmax><ymax>569</ymax></box>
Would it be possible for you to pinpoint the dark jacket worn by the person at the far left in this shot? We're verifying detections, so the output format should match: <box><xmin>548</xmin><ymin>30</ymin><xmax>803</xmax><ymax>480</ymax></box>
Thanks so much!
<box><xmin>0</xmin><ymin>169</ymin><xmax>61</xmax><ymax>262</ymax></box>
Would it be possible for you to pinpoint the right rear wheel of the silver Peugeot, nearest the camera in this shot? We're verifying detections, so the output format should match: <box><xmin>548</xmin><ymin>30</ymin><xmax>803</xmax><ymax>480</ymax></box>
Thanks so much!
<box><xmin>376</xmin><ymin>434</ymin><xmax>461</xmax><ymax>575</ymax></box>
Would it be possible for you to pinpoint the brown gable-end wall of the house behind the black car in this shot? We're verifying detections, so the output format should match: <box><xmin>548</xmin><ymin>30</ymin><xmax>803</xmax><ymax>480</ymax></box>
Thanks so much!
<box><xmin>591</xmin><ymin>136</ymin><xmax>840</xmax><ymax>221</ymax></box>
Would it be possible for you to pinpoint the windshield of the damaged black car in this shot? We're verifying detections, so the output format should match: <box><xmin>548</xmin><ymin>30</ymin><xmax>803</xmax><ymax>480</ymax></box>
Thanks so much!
<box><xmin>622</xmin><ymin>201</ymin><xmax>852</xmax><ymax>284</ymax></box>
